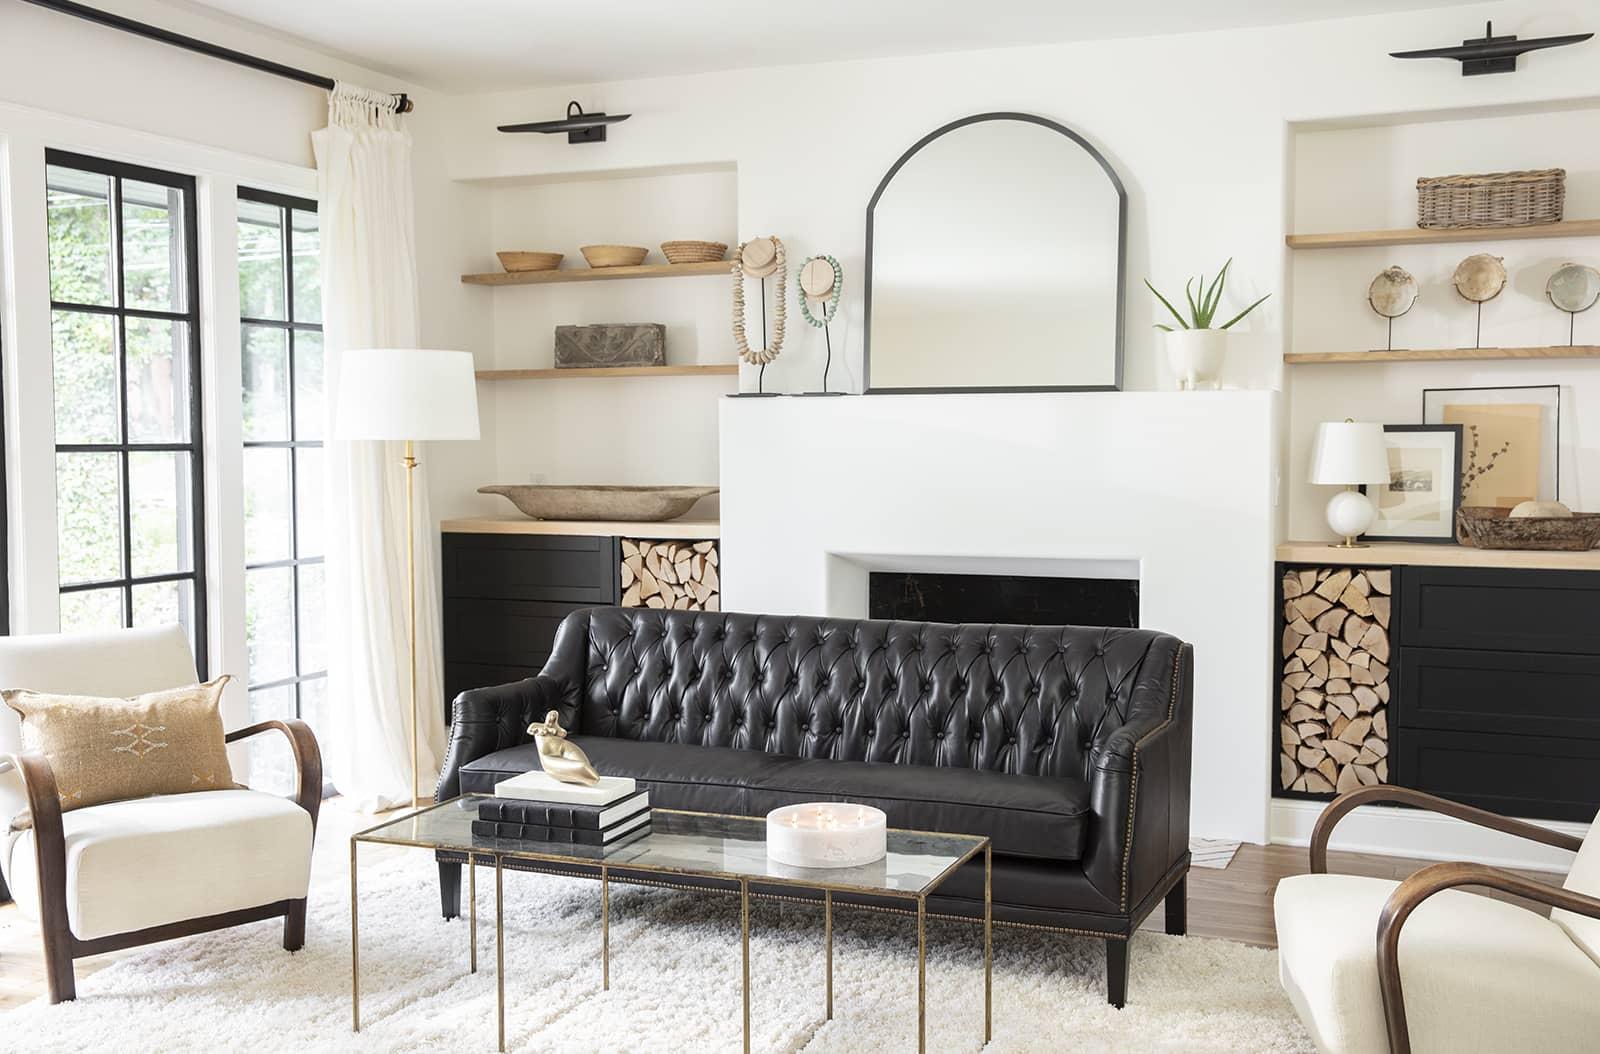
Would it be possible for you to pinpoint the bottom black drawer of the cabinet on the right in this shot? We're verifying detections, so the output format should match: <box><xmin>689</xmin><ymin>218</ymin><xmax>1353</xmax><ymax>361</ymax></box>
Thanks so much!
<box><xmin>1394</xmin><ymin>729</ymin><xmax>1600</xmax><ymax>822</ymax></box>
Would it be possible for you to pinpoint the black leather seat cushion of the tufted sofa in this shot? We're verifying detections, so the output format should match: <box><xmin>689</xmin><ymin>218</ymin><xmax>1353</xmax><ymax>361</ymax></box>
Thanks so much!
<box><xmin>461</xmin><ymin>736</ymin><xmax>1090</xmax><ymax>860</ymax></box>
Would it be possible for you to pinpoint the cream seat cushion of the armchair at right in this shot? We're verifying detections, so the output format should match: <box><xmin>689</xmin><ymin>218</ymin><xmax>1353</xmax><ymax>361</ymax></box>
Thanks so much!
<box><xmin>1272</xmin><ymin>875</ymin><xmax>1600</xmax><ymax>1054</ymax></box>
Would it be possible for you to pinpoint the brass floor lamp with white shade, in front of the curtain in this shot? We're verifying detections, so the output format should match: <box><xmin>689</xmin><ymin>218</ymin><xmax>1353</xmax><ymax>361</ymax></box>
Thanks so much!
<box><xmin>333</xmin><ymin>347</ymin><xmax>478</xmax><ymax>808</ymax></box>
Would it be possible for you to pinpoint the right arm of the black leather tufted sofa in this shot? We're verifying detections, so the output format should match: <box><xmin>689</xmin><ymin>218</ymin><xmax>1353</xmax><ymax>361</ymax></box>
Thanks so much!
<box><xmin>1083</xmin><ymin>638</ymin><xmax>1194</xmax><ymax>912</ymax></box>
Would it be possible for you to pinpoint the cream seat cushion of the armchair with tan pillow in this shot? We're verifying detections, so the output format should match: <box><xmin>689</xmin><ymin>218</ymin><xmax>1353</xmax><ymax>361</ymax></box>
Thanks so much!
<box><xmin>3</xmin><ymin>790</ymin><xmax>312</xmax><ymax>940</ymax></box>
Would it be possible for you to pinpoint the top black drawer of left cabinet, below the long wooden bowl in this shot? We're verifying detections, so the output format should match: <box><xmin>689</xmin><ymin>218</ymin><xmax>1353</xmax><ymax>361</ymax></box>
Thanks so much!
<box><xmin>442</xmin><ymin>534</ymin><xmax>618</xmax><ymax>606</ymax></box>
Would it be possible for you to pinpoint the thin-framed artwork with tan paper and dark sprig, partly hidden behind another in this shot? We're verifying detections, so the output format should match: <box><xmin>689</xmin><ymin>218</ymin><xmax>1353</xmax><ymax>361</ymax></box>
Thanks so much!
<box><xmin>1422</xmin><ymin>384</ymin><xmax>1562</xmax><ymax>509</ymax></box>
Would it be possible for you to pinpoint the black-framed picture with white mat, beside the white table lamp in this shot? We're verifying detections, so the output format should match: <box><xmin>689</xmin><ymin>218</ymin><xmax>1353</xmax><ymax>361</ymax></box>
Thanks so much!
<box><xmin>1362</xmin><ymin>424</ymin><xmax>1466</xmax><ymax>542</ymax></box>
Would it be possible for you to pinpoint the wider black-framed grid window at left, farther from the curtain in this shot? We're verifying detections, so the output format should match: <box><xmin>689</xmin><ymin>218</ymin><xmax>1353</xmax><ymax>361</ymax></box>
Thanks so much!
<box><xmin>45</xmin><ymin>150</ymin><xmax>206</xmax><ymax>677</ymax></box>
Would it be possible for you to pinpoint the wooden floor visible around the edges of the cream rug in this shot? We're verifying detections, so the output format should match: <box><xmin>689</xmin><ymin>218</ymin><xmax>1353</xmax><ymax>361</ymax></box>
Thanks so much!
<box><xmin>0</xmin><ymin>838</ymin><xmax>1562</xmax><ymax>1011</ymax></box>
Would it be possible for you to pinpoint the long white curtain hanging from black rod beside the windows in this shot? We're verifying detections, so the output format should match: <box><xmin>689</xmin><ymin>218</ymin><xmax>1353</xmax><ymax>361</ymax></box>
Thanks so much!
<box><xmin>312</xmin><ymin>83</ymin><xmax>445</xmax><ymax>811</ymax></box>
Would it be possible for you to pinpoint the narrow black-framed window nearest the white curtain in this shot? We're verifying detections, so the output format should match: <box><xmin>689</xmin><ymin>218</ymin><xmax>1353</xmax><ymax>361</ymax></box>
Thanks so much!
<box><xmin>238</xmin><ymin>187</ymin><xmax>328</xmax><ymax>751</ymax></box>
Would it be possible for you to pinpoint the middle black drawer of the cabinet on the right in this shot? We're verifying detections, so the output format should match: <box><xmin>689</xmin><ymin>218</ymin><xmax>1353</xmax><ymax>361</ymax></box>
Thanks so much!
<box><xmin>1394</xmin><ymin>648</ymin><xmax>1600</xmax><ymax>738</ymax></box>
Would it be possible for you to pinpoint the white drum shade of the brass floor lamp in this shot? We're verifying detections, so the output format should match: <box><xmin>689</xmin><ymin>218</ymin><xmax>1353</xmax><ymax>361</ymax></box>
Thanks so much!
<box><xmin>333</xmin><ymin>347</ymin><xmax>478</xmax><ymax>440</ymax></box>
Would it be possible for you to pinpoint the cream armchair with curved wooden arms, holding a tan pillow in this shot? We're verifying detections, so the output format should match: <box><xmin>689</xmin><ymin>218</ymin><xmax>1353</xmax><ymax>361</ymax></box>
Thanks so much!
<box><xmin>0</xmin><ymin>625</ymin><xmax>322</xmax><ymax>1003</ymax></box>
